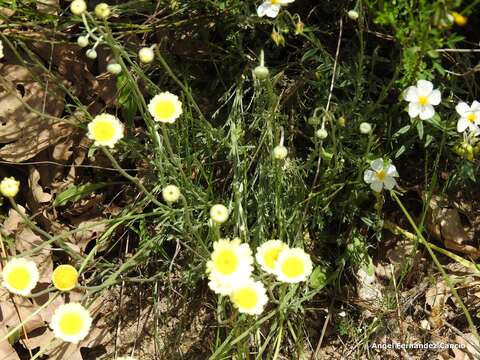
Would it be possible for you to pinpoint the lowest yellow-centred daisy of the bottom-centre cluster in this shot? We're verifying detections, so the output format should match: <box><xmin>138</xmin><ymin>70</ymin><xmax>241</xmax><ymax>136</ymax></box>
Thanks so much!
<box><xmin>230</xmin><ymin>279</ymin><xmax>268</xmax><ymax>315</ymax></box>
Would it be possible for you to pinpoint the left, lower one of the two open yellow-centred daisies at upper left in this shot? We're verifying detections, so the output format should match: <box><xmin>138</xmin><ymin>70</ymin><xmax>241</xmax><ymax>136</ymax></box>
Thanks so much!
<box><xmin>87</xmin><ymin>113</ymin><xmax>124</xmax><ymax>148</ymax></box>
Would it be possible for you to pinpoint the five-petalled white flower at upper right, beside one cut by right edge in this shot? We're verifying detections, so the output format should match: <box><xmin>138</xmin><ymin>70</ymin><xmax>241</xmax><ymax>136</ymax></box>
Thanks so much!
<box><xmin>403</xmin><ymin>80</ymin><xmax>442</xmax><ymax>120</ymax></box>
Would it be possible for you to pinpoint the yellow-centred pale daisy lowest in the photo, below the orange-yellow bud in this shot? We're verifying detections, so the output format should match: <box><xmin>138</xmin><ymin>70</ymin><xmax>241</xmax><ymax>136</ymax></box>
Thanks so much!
<box><xmin>50</xmin><ymin>303</ymin><xmax>92</xmax><ymax>344</ymax></box>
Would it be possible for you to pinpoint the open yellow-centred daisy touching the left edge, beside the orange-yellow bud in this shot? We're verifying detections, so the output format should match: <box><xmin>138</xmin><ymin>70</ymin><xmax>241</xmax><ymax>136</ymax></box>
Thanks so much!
<box><xmin>2</xmin><ymin>258</ymin><xmax>39</xmax><ymax>296</ymax></box>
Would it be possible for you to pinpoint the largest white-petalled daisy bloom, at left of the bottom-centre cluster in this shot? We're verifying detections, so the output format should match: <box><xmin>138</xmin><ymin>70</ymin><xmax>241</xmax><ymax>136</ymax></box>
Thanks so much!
<box><xmin>207</xmin><ymin>238</ymin><xmax>253</xmax><ymax>295</ymax></box>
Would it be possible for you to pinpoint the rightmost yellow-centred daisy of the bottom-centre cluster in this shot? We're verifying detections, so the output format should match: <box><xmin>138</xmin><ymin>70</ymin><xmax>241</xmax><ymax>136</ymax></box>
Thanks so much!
<box><xmin>275</xmin><ymin>248</ymin><xmax>313</xmax><ymax>283</ymax></box>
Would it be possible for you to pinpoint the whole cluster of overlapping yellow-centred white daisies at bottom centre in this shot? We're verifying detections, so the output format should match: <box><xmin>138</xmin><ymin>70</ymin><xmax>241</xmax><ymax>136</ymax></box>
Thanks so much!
<box><xmin>207</xmin><ymin>238</ymin><xmax>312</xmax><ymax>315</ymax></box>
